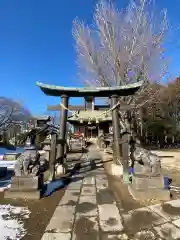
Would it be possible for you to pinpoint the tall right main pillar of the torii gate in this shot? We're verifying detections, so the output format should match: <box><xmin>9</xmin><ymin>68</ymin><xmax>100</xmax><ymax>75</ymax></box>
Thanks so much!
<box><xmin>111</xmin><ymin>95</ymin><xmax>122</xmax><ymax>165</ymax></box>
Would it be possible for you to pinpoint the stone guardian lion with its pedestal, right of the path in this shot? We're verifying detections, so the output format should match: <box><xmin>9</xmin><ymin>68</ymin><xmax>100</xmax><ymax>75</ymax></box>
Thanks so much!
<box><xmin>129</xmin><ymin>145</ymin><xmax>170</xmax><ymax>200</ymax></box>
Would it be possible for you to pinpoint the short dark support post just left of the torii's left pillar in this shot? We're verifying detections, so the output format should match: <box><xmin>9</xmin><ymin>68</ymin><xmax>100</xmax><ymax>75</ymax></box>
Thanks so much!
<box><xmin>49</xmin><ymin>134</ymin><xmax>57</xmax><ymax>181</ymax></box>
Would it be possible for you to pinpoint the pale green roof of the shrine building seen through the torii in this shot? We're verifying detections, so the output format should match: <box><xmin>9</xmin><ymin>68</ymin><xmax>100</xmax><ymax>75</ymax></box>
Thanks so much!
<box><xmin>68</xmin><ymin>110</ymin><xmax>112</xmax><ymax>122</ymax></box>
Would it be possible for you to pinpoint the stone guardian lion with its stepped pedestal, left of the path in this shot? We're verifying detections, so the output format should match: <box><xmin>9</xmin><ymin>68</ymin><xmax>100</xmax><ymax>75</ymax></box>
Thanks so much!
<box><xmin>5</xmin><ymin>146</ymin><xmax>48</xmax><ymax>199</ymax></box>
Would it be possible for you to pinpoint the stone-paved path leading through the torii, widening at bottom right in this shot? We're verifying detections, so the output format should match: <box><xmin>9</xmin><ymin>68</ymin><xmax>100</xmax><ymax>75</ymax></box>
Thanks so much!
<box><xmin>42</xmin><ymin>149</ymin><xmax>180</xmax><ymax>240</ymax></box>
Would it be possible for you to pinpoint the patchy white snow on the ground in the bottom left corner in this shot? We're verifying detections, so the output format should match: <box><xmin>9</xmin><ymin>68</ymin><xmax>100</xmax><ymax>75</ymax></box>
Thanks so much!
<box><xmin>0</xmin><ymin>205</ymin><xmax>30</xmax><ymax>240</ymax></box>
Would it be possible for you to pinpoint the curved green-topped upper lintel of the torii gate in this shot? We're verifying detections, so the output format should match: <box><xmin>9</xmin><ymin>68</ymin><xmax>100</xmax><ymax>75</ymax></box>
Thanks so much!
<box><xmin>36</xmin><ymin>81</ymin><xmax>144</xmax><ymax>97</ymax></box>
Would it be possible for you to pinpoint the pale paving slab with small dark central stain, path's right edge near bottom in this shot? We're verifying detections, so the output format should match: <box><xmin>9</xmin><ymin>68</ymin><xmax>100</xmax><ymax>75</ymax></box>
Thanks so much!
<box><xmin>98</xmin><ymin>204</ymin><xmax>123</xmax><ymax>232</ymax></box>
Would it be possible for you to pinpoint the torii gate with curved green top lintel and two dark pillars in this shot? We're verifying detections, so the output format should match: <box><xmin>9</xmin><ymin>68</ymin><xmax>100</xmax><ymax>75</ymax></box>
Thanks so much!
<box><xmin>37</xmin><ymin>81</ymin><xmax>144</xmax><ymax>175</ymax></box>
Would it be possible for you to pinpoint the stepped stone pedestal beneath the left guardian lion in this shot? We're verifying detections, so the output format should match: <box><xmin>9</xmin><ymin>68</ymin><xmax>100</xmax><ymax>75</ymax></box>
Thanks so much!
<box><xmin>4</xmin><ymin>175</ymin><xmax>43</xmax><ymax>200</ymax></box>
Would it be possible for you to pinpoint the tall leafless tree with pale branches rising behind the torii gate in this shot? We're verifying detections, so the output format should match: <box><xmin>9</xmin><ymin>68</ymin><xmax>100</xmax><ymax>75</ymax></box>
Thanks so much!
<box><xmin>73</xmin><ymin>0</ymin><xmax>168</xmax><ymax>106</ymax></box>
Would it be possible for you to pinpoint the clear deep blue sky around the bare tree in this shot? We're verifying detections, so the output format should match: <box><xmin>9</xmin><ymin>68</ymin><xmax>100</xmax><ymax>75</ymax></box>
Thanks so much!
<box><xmin>0</xmin><ymin>0</ymin><xmax>180</xmax><ymax>114</ymax></box>
